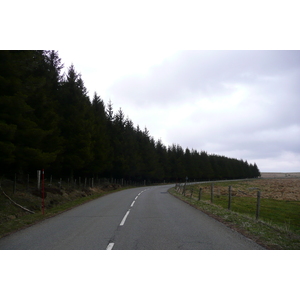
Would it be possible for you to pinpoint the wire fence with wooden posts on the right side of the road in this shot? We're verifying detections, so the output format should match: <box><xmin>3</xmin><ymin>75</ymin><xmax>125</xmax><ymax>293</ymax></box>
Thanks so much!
<box><xmin>175</xmin><ymin>181</ymin><xmax>300</xmax><ymax>233</ymax></box>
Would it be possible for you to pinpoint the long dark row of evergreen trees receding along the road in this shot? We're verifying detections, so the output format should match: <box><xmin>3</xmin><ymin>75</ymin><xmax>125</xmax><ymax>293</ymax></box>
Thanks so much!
<box><xmin>0</xmin><ymin>51</ymin><xmax>260</xmax><ymax>182</ymax></box>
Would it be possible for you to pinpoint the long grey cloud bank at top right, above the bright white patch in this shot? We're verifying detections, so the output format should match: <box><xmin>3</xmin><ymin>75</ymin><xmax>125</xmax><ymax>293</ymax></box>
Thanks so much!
<box><xmin>111</xmin><ymin>51</ymin><xmax>300</xmax><ymax>106</ymax></box>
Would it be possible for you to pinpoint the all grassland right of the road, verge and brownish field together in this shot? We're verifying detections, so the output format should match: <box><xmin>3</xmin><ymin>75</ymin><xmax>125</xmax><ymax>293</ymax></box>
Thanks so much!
<box><xmin>170</xmin><ymin>178</ymin><xmax>300</xmax><ymax>250</ymax></box>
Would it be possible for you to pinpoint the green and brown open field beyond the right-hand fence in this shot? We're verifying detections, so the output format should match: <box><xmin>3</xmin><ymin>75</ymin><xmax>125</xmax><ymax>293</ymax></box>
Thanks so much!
<box><xmin>179</xmin><ymin>178</ymin><xmax>300</xmax><ymax>234</ymax></box>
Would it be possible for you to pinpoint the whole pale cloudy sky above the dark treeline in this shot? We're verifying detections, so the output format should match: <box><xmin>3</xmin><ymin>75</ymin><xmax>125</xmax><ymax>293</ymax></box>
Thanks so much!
<box><xmin>59</xmin><ymin>49</ymin><xmax>300</xmax><ymax>172</ymax></box>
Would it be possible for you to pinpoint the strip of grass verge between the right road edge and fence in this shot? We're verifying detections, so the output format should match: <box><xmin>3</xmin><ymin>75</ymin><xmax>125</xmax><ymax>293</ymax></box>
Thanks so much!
<box><xmin>169</xmin><ymin>188</ymin><xmax>300</xmax><ymax>250</ymax></box>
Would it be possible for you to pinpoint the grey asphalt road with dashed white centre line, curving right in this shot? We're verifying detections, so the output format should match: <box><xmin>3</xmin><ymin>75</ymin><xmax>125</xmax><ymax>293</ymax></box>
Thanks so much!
<box><xmin>0</xmin><ymin>186</ymin><xmax>264</xmax><ymax>250</ymax></box>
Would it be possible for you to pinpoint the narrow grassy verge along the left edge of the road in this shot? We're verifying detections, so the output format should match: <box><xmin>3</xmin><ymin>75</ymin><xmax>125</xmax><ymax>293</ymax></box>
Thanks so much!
<box><xmin>0</xmin><ymin>187</ymin><xmax>130</xmax><ymax>238</ymax></box>
